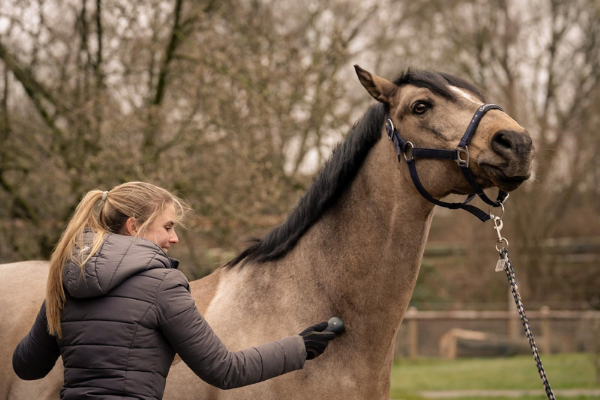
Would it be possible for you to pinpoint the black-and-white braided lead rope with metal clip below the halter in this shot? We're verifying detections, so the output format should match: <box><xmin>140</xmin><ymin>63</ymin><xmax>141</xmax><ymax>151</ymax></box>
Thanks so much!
<box><xmin>490</xmin><ymin>211</ymin><xmax>556</xmax><ymax>400</ymax></box>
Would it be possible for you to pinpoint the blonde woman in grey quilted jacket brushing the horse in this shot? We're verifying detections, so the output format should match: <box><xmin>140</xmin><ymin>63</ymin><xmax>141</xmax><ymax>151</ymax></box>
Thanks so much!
<box><xmin>13</xmin><ymin>182</ymin><xmax>335</xmax><ymax>399</ymax></box>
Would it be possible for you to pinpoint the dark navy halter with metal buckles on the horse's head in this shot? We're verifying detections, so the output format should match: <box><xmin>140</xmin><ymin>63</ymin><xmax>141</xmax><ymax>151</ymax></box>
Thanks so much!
<box><xmin>385</xmin><ymin>104</ymin><xmax>508</xmax><ymax>222</ymax></box>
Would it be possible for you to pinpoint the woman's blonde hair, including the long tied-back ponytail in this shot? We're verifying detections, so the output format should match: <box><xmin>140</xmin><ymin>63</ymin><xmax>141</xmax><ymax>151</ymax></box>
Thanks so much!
<box><xmin>46</xmin><ymin>182</ymin><xmax>190</xmax><ymax>337</ymax></box>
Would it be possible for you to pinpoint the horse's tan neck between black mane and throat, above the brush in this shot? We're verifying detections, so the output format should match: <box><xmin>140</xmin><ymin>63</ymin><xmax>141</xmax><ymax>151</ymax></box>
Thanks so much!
<box><xmin>284</xmin><ymin>134</ymin><xmax>433</xmax><ymax>337</ymax></box>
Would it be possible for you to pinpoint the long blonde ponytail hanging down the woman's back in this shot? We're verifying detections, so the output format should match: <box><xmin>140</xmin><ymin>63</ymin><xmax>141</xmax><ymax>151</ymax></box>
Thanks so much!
<box><xmin>46</xmin><ymin>190</ymin><xmax>106</xmax><ymax>338</ymax></box>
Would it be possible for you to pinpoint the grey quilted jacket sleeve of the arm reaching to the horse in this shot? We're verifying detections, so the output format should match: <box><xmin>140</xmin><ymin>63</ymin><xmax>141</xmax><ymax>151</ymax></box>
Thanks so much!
<box><xmin>156</xmin><ymin>270</ymin><xmax>306</xmax><ymax>389</ymax></box>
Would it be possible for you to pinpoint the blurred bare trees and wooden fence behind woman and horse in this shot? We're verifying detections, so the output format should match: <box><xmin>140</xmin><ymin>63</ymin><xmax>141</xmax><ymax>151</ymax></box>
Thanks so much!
<box><xmin>0</xmin><ymin>0</ymin><xmax>600</xmax><ymax>396</ymax></box>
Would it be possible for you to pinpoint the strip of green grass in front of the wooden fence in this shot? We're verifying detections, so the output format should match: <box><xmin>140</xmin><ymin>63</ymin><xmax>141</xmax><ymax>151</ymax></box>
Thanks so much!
<box><xmin>390</xmin><ymin>354</ymin><xmax>600</xmax><ymax>400</ymax></box>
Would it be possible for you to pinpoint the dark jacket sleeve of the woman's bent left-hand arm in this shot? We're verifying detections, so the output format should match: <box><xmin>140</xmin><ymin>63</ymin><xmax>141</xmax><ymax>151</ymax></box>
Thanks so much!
<box><xmin>13</xmin><ymin>301</ymin><xmax>60</xmax><ymax>380</ymax></box>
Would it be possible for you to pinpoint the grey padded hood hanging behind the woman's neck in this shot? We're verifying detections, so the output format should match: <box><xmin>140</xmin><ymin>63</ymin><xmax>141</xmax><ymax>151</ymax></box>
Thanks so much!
<box><xmin>63</xmin><ymin>231</ymin><xmax>179</xmax><ymax>298</ymax></box>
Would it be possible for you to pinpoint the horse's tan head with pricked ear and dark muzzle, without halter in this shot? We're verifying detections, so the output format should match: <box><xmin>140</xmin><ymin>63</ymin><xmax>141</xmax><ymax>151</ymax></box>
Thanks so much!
<box><xmin>356</xmin><ymin>66</ymin><xmax>535</xmax><ymax>197</ymax></box>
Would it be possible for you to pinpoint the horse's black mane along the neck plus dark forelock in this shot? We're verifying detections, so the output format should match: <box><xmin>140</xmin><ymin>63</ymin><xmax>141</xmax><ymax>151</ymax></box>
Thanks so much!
<box><xmin>225</xmin><ymin>70</ymin><xmax>484</xmax><ymax>268</ymax></box>
